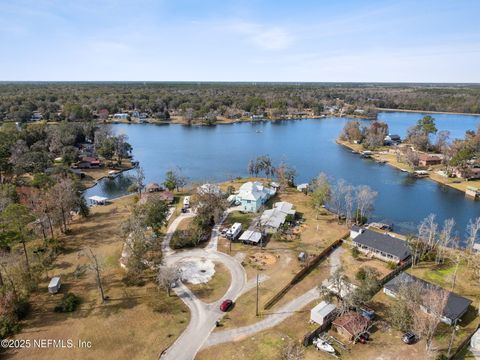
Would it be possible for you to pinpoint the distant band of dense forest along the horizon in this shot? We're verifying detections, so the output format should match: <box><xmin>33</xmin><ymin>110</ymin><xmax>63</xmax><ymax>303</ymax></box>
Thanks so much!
<box><xmin>0</xmin><ymin>82</ymin><xmax>480</xmax><ymax>122</ymax></box>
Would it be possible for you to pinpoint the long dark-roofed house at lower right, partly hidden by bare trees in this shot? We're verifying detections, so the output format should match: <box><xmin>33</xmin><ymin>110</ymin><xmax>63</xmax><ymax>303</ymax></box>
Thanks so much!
<box><xmin>383</xmin><ymin>272</ymin><xmax>472</xmax><ymax>325</ymax></box>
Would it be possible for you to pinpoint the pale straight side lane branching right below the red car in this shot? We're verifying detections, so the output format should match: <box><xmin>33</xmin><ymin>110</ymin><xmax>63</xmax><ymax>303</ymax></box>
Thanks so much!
<box><xmin>203</xmin><ymin>288</ymin><xmax>320</xmax><ymax>348</ymax></box>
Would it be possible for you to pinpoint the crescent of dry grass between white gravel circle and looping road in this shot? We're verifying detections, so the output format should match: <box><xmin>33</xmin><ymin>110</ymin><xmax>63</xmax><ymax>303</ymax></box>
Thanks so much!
<box><xmin>186</xmin><ymin>263</ymin><xmax>231</xmax><ymax>303</ymax></box>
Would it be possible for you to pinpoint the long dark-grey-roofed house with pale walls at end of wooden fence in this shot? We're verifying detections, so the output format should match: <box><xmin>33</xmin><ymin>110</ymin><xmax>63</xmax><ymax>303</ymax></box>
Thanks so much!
<box><xmin>352</xmin><ymin>229</ymin><xmax>411</xmax><ymax>263</ymax></box>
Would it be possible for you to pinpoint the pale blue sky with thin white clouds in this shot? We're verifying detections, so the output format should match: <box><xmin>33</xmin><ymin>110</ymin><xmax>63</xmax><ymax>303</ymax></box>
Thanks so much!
<box><xmin>0</xmin><ymin>0</ymin><xmax>480</xmax><ymax>83</ymax></box>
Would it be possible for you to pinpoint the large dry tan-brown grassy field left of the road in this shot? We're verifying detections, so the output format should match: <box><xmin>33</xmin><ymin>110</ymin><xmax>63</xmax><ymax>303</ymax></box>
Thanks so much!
<box><xmin>5</xmin><ymin>197</ymin><xmax>190</xmax><ymax>359</ymax></box>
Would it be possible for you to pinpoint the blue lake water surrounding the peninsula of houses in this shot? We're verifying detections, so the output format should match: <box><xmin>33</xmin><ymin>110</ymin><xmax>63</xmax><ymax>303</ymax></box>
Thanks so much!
<box><xmin>86</xmin><ymin>113</ymin><xmax>480</xmax><ymax>237</ymax></box>
